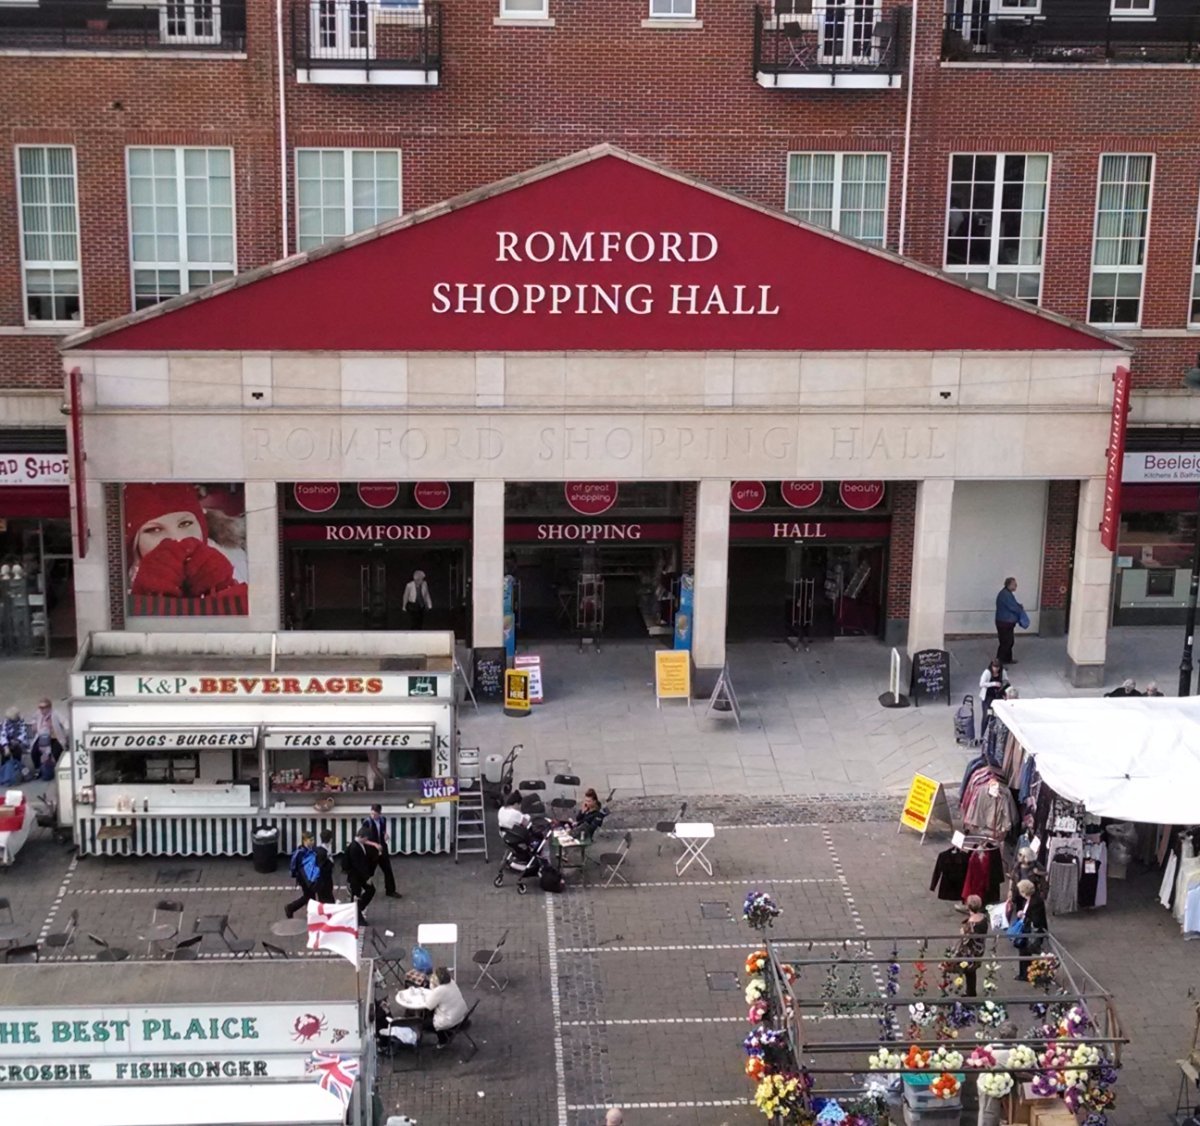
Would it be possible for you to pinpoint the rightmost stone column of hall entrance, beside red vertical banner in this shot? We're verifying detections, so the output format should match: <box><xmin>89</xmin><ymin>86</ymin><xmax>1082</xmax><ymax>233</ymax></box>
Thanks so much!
<box><xmin>1067</xmin><ymin>477</ymin><xmax>1112</xmax><ymax>688</ymax></box>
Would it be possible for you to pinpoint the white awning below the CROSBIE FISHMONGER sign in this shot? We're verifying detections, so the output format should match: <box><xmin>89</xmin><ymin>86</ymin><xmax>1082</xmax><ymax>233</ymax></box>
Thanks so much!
<box><xmin>0</xmin><ymin>1080</ymin><xmax>346</xmax><ymax>1126</ymax></box>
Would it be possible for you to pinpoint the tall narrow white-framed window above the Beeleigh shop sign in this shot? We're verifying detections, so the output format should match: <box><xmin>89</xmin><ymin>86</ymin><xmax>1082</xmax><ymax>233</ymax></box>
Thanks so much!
<box><xmin>1087</xmin><ymin>154</ymin><xmax>1154</xmax><ymax>327</ymax></box>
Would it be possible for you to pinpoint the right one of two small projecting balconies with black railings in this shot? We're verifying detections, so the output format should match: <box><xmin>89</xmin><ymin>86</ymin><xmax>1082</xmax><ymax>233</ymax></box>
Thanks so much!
<box><xmin>754</xmin><ymin>0</ymin><xmax>910</xmax><ymax>85</ymax></box>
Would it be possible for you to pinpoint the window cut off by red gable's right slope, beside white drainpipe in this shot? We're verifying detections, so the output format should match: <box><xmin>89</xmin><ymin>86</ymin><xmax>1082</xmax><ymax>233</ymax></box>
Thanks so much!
<box><xmin>785</xmin><ymin>152</ymin><xmax>888</xmax><ymax>246</ymax></box>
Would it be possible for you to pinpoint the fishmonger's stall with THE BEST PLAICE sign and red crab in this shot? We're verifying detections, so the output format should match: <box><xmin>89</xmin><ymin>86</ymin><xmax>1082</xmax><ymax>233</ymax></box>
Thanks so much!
<box><xmin>0</xmin><ymin>957</ymin><xmax>376</xmax><ymax>1126</ymax></box>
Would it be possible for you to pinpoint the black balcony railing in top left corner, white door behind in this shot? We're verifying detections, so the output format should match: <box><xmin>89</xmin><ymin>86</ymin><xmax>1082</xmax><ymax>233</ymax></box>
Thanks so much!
<box><xmin>0</xmin><ymin>0</ymin><xmax>246</xmax><ymax>52</ymax></box>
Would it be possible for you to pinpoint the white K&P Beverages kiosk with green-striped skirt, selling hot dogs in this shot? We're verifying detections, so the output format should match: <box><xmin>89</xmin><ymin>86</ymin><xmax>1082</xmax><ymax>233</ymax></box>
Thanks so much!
<box><xmin>68</xmin><ymin>631</ymin><xmax>457</xmax><ymax>856</ymax></box>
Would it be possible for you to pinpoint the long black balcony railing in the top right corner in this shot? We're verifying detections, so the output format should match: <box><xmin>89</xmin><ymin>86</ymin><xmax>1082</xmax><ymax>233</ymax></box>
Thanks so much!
<box><xmin>942</xmin><ymin>12</ymin><xmax>1200</xmax><ymax>62</ymax></box>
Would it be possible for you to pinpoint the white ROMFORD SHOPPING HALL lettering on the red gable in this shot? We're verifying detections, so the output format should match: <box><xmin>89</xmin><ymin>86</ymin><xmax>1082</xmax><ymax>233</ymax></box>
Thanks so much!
<box><xmin>431</xmin><ymin>230</ymin><xmax>779</xmax><ymax>317</ymax></box>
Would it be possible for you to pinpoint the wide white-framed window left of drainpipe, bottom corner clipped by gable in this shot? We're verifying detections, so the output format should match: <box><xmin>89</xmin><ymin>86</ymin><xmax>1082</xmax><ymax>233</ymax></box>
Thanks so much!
<box><xmin>128</xmin><ymin>148</ymin><xmax>238</xmax><ymax>309</ymax></box>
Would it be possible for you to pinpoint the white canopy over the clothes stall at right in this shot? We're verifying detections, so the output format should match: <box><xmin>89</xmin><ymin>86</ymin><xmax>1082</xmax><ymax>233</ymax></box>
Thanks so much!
<box><xmin>994</xmin><ymin>696</ymin><xmax>1200</xmax><ymax>825</ymax></box>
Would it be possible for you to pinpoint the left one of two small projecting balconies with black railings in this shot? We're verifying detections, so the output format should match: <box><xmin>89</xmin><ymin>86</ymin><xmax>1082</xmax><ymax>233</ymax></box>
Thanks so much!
<box><xmin>292</xmin><ymin>0</ymin><xmax>442</xmax><ymax>71</ymax></box>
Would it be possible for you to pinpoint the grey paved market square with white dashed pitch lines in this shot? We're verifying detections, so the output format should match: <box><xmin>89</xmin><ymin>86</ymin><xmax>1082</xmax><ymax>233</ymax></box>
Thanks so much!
<box><xmin>0</xmin><ymin>630</ymin><xmax>1198</xmax><ymax>1126</ymax></box>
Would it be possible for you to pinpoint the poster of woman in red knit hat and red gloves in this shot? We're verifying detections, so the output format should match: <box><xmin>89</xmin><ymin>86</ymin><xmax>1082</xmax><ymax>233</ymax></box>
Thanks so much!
<box><xmin>124</xmin><ymin>484</ymin><xmax>248</xmax><ymax>617</ymax></box>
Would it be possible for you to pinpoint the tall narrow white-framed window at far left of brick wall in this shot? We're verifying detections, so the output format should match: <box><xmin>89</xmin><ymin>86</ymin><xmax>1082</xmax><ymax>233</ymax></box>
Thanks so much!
<box><xmin>17</xmin><ymin>145</ymin><xmax>82</xmax><ymax>324</ymax></box>
